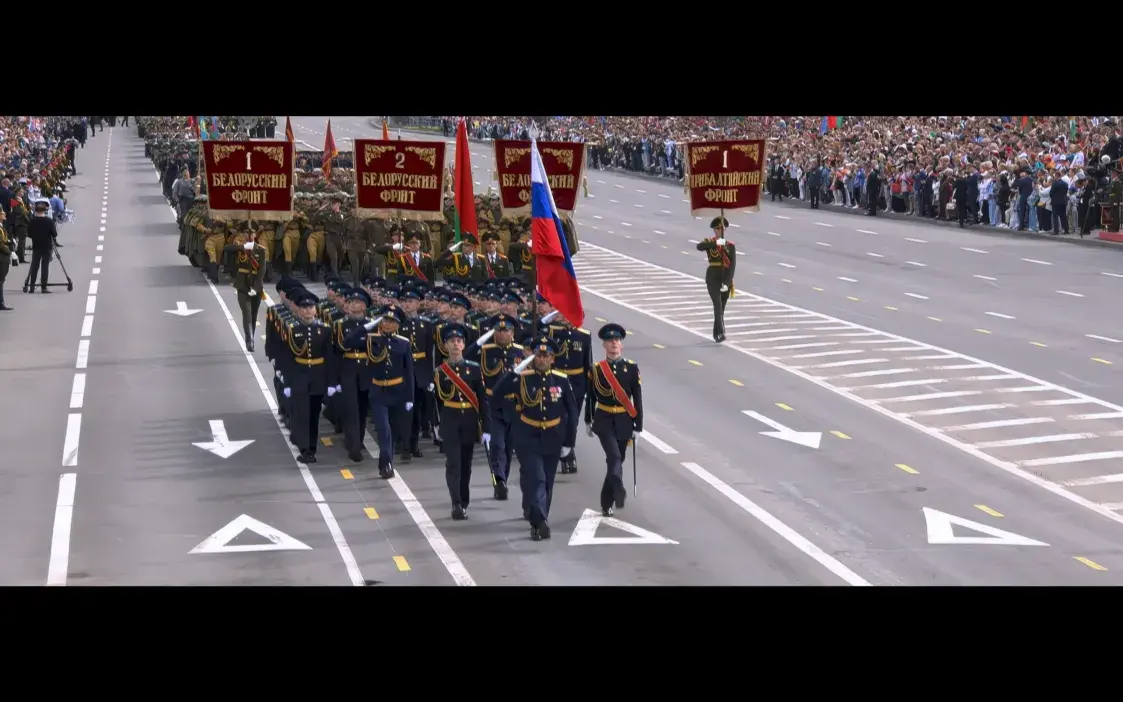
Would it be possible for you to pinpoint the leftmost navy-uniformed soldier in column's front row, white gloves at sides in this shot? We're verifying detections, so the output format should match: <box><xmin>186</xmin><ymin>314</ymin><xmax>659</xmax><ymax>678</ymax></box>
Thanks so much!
<box><xmin>281</xmin><ymin>292</ymin><xmax>335</xmax><ymax>463</ymax></box>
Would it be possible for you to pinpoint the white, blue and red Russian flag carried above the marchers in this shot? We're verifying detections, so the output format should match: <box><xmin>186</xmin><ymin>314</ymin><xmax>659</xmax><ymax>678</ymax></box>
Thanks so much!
<box><xmin>530</xmin><ymin>139</ymin><xmax>585</xmax><ymax>327</ymax></box>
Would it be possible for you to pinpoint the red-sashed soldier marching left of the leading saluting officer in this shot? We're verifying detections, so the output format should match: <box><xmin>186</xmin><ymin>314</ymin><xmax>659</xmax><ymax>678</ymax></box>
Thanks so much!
<box><xmin>432</xmin><ymin>322</ymin><xmax>491</xmax><ymax>520</ymax></box>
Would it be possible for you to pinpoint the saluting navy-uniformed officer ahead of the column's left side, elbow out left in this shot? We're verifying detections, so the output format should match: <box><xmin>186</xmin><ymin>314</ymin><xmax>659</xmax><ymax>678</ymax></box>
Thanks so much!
<box><xmin>344</xmin><ymin>307</ymin><xmax>414</xmax><ymax>480</ymax></box>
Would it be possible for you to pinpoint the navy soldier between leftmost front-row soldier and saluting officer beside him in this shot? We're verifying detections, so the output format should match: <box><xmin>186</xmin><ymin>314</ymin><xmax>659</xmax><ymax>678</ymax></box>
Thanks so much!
<box><xmin>331</xmin><ymin>290</ymin><xmax>371</xmax><ymax>463</ymax></box>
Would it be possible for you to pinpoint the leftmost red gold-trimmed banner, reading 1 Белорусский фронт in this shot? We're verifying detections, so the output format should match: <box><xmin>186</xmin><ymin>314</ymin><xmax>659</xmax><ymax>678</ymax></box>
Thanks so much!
<box><xmin>201</xmin><ymin>139</ymin><xmax>293</xmax><ymax>221</ymax></box>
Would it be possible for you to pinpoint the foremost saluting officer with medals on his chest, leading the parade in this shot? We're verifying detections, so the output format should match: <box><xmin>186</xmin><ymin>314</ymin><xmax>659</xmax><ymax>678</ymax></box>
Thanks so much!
<box><xmin>494</xmin><ymin>336</ymin><xmax>581</xmax><ymax>541</ymax></box>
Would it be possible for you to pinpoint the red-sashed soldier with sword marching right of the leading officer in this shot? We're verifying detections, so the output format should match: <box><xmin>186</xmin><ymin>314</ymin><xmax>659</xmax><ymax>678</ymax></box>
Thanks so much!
<box><xmin>585</xmin><ymin>323</ymin><xmax>643</xmax><ymax>517</ymax></box>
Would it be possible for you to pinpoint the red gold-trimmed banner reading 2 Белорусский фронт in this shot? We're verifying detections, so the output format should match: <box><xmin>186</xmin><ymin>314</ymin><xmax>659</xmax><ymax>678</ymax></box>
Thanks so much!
<box><xmin>355</xmin><ymin>139</ymin><xmax>447</xmax><ymax>221</ymax></box>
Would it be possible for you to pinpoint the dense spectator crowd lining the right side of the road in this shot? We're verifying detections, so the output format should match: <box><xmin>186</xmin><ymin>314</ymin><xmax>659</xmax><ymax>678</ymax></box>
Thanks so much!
<box><xmin>424</xmin><ymin>116</ymin><xmax>1120</xmax><ymax>233</ymax></box>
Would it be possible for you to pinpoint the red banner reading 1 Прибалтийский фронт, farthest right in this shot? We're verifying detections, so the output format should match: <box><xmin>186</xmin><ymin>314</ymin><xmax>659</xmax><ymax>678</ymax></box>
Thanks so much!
<box><xmin>685</xmin><ymin>139</ymin><xmax>767</xmax><ymax>217</ymax></box>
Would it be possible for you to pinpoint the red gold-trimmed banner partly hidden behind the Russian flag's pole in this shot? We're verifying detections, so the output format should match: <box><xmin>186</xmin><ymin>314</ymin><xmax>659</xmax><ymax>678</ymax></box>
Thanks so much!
<box><xmin>495</xmin><ymin>139</ymin><xmax>585</xmax><ymax>217</ymax></box>
